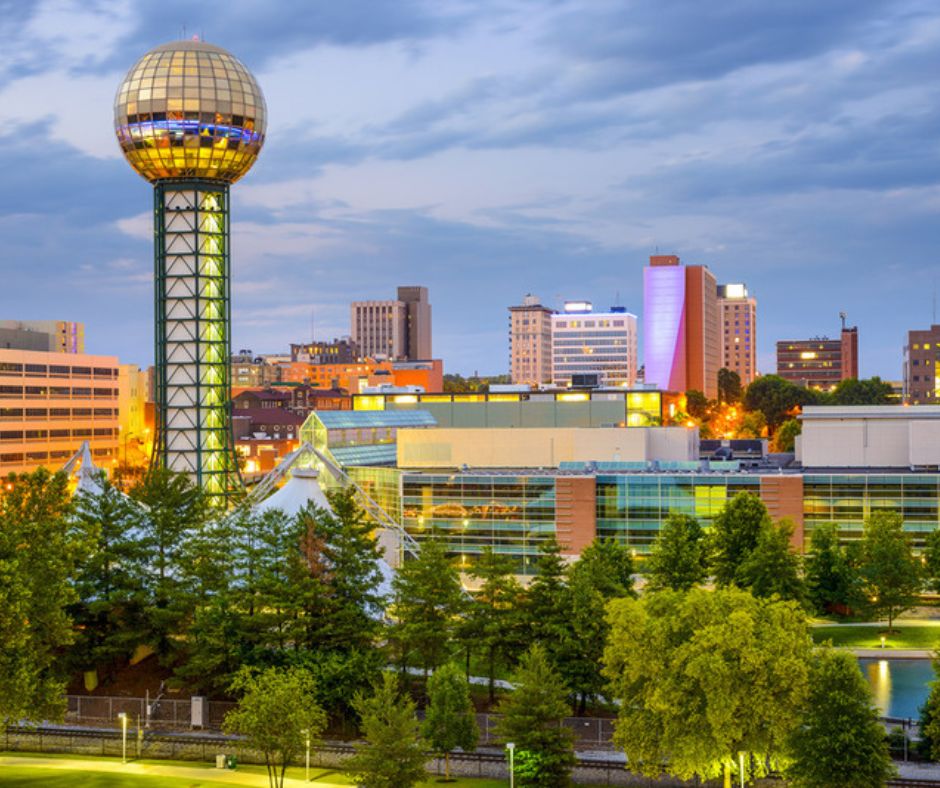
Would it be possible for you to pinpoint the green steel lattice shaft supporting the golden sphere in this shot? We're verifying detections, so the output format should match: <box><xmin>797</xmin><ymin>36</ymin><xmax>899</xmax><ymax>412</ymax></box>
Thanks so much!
<box><xmin>153</xmin><ymin>179</ymin><xmax>241</xmax><ymax>505</ymax></box>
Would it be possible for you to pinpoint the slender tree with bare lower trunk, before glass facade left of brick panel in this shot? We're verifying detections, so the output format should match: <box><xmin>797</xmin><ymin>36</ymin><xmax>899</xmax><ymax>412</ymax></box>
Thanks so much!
<box><xmin>462</xmin><ymin>547</ymin><xmax>522</xmax><ymax>703</ymax></box>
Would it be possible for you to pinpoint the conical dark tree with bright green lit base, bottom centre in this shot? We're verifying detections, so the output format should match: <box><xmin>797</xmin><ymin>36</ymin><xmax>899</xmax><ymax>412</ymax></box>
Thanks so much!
<box><xmin>497</xmin><ymin>644</ymin><xmax>575</xmax><ymax>788</ymax></box>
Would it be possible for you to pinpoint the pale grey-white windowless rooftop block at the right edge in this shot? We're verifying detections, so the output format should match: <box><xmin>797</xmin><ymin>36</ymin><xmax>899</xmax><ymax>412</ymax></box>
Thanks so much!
<box><xmin>797</xmin><ymin>405</ymin><xmax>940</xmax><ymax>468</ymax></box>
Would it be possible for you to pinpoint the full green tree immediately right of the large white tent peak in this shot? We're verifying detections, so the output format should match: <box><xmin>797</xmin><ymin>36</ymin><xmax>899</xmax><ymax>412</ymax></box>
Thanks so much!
<box><xmin>391</xmin><ymin>538</ymin><xmax>464</xmax><ymax>676</ymax></box>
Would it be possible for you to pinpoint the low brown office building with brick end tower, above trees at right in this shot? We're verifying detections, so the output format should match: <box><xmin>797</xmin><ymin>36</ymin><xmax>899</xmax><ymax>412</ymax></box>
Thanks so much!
<box><xmin>777</xmin><ymin>326</ymin><xmax>858</xmax><ymax>391</ymax></box>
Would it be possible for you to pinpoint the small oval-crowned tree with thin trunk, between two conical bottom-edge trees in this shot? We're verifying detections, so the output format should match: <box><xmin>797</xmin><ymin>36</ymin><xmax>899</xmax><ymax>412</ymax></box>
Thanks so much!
<box><xmin>423</xmin><ymin>663</ymin><xmax>480</xmax><ymax>782</ymax></box>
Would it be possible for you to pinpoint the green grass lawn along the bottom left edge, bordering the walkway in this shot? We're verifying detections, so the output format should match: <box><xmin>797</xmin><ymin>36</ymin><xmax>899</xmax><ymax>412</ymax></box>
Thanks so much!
<box><xmin>0</xmin><ymin>752</ymin><xmax>505</xmax><ymax>788</ymax></box>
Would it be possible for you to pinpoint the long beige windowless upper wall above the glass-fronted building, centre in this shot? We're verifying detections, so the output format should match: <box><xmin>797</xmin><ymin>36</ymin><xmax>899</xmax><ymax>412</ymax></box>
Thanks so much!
<box><xmin>397</xmin><ymin>427</ymin><xmax>698</xmax><ymax>468</ymax></box>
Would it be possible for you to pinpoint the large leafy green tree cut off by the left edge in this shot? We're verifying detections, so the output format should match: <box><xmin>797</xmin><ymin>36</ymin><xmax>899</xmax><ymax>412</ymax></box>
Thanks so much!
<box><xmin>0</xmin><ymin>469</ymin><xmax>79</xmax><ymax>726</ymax></box>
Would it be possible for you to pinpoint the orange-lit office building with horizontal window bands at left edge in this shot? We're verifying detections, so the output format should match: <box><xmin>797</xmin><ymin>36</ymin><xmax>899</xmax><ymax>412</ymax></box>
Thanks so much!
<box><xmin>0</xmin><ymin>349</ymin><xmax>121</xmax><ymax>476</ymax></box>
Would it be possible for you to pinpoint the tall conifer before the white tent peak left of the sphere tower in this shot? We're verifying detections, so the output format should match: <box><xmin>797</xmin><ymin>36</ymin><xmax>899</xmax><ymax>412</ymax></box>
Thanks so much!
<box><xmin>69</xmin><ymin>473</ymin><xmax>147</xmax><ymax>676</ymax></box>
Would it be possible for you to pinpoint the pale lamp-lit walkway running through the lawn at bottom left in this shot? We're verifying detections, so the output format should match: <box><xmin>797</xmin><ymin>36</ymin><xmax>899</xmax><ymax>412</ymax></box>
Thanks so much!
<box><xmin>0</xmin><ymin>755</ymin><xmax>349</xmax><ymax>788</ymax></box>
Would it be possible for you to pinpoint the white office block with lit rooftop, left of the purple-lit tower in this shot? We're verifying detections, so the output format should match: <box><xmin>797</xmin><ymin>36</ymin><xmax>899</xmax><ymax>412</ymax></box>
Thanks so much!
<box><xmin>550</xmin><ymin>301</ymin><xmax>637</xmax><ymax>388</ymax></box>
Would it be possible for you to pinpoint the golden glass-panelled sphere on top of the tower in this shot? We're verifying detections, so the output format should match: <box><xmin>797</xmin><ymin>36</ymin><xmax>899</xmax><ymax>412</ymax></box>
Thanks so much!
<box><xmin>114</xmin><ymin>40</ymin><xmax>267</xmax><ymax>183</ymax></box>
